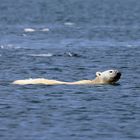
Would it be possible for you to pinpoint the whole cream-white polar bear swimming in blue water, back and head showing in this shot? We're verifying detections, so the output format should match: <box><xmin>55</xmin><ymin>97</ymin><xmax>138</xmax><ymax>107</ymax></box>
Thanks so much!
<box><xmin>13</xmin><ymin>70</ymin><xmax>121</xmax><ymax>85</ymax></box>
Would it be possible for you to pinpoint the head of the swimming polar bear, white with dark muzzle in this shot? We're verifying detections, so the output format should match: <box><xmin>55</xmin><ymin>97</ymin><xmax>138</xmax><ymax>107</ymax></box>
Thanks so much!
<box><xmin>96</xmin><ymin>70</ymin><xmax>121</xmax><ymax>84</ymax></box>
